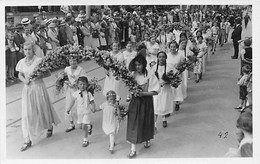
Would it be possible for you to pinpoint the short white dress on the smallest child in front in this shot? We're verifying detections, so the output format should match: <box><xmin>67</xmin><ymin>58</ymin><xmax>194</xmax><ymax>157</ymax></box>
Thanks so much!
<box><xmin>99</xmin><ymin>101</ymin><xmax>118</xmax><ymax>135</ymax></box>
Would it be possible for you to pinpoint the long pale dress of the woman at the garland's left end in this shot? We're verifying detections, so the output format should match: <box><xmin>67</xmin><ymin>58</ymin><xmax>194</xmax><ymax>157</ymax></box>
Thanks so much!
<box><xmin>16</xmin><ymin>56</ymin><xmax>60</xmax><ymax>141</ymax></box>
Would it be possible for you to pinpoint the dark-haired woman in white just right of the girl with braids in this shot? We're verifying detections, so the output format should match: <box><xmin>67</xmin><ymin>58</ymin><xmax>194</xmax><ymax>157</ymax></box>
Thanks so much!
<box><xmin>167</xmin><ymin>41</ymin><xmax>185</xmax><ymax>111</ymax></box>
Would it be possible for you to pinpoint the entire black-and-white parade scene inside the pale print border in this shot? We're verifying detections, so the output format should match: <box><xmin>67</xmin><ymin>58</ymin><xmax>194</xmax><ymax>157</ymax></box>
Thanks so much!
<box><xmin>4</xmin><ymin>5</ymin><xmax>253</xmax><ymax>159</ymax></box>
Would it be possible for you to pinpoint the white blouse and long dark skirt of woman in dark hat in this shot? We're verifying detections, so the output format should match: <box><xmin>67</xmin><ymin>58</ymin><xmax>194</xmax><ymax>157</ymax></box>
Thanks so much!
<box><xmin>126</xmin><ymin>73</ymin><xmax>160</xmax><ymax>144</ymax></box>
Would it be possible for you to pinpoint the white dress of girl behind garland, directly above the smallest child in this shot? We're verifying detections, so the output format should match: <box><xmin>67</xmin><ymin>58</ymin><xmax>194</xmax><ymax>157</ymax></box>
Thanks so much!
<box><xmin>103</xmin><ymin>51</ymin><xmax>124</xmax><ymax>100</ymax></box>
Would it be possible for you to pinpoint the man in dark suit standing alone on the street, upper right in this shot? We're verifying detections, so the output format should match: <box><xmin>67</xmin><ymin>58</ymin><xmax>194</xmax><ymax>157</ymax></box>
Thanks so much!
<box><xmin>231</xmin><ymin>18</ymin><xmax>242</xmax><ymax>59</ymax></box>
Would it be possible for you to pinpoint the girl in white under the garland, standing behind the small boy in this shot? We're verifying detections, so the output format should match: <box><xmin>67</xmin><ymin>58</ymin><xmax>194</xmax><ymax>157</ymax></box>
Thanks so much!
<box><xmin>64</xmin><ymin>57</ymin><xmax>85</xmax><ymax>132</ymax></box>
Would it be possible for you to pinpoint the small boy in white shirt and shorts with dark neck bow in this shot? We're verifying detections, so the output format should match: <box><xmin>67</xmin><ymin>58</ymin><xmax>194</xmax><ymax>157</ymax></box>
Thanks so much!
<box><xmin>66</xmin><ymin>76</ymin><xmax>95</xmax><ymax>147</ymax></box>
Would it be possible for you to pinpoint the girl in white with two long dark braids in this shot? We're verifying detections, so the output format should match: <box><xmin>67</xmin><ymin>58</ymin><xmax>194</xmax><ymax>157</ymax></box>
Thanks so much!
<box><xmin>153</xmin><ymin>51</ymin><xmax>173</xmax><ymax>131</ymax></box>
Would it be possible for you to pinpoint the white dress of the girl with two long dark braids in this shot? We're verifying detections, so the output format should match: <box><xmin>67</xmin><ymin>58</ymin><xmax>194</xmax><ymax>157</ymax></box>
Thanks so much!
<box><xmin>153</xmin><ymin>65</ymin><xmax>174</xmax><ymax>116</ymax></box>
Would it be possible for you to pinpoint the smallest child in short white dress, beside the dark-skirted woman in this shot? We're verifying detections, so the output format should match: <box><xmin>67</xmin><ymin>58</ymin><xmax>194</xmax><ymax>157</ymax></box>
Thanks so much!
<box><xmin>95</xmin><ymin>90</ymin><xmax>120</xmax><ymax>154</ymax></box>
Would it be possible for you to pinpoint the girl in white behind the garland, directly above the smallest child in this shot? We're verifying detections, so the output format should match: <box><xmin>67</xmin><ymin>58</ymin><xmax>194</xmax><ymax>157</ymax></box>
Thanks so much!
<box><xmin>103</xmin><ymin>43</ymin><xmax>124</xmax><ymax>101</ymax></box>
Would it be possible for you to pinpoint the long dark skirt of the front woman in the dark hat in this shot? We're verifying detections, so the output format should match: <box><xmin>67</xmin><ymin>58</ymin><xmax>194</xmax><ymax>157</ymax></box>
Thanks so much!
<box><xmin>126</xmin><ymin>96</ymin><xmax>154</xmax><ymax>144</ymax></box>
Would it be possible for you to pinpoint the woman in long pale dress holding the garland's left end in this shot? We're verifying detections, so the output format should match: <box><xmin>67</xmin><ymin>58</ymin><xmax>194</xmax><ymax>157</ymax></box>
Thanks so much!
<box><xmin>16</xmin><ymin>42</ymin><xmax>60</xmax><ymax>151</ymax></box>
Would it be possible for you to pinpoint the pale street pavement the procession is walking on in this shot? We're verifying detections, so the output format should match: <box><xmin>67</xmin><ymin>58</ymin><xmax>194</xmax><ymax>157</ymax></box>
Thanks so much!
<box><xmin>6</xmin><ymin>19</ymin><xmax>252</xmax><ymax>159</ymax></box>
